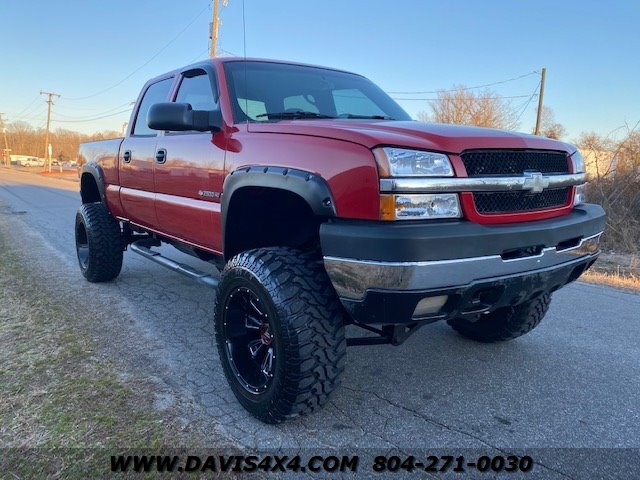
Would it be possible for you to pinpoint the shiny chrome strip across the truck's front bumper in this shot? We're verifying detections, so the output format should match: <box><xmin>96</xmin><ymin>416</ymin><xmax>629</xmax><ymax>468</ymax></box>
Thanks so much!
<box><xmin>324</xmin><ymin>232</ymin><xmax>602</xmax><ymax>300</ymax></box>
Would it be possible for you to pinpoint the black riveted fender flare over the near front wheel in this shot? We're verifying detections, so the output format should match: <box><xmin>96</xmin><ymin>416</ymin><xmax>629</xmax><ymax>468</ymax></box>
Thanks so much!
<box><xmin>221</xmin><ymin>165</ymin><xmax>337</xmax><ymax>253</ymax></box>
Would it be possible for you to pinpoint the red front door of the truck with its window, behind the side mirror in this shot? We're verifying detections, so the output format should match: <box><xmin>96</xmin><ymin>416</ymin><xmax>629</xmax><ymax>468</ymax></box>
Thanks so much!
<box><xmin>154</xmin><ymin>68</ymin><xmax>225</xmax><ymax>253</ymax></box>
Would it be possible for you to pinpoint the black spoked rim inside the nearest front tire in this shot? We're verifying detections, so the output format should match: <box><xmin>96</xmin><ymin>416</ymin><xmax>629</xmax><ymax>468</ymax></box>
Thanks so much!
<box><xmin>223</xmin><ymin>287</ymin><xmax>276</xmax><ymax>394</ymax></box>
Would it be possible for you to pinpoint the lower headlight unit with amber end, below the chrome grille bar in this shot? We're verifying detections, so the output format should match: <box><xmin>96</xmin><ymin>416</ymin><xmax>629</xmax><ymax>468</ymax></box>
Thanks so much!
<box><xmin>380</xmin><ymin>193</ymin><xmax>462</xmax><ymax>220</ymax></box>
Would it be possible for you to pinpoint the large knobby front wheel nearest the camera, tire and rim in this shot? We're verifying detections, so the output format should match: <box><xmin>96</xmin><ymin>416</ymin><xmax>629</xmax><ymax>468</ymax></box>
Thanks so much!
<box><xmin>215</xmin><ymin>248</ymin><xmax>346</xmax><ymax>423</ymax></box>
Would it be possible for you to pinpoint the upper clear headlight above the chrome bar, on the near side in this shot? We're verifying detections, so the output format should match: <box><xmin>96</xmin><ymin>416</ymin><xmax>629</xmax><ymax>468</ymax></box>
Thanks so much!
<box><xmin>373</xmin><ymin>147</ymin><xmax>453</xmax><ymax>177</ymax></box>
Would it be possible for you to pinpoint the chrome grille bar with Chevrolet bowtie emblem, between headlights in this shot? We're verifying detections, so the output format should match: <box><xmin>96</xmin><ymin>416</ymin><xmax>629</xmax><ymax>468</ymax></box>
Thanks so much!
<box><xmin>380</xmin><ymin>173</ymin><xmax>587</xmax><ymax>193</ymax></box>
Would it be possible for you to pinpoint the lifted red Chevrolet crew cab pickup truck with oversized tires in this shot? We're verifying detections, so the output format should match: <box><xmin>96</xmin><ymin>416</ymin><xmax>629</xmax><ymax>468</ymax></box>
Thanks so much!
<box><xmin>75</xmin><ymin>58</ymin><xmax>604</xmax><ymax>423</ymax></box>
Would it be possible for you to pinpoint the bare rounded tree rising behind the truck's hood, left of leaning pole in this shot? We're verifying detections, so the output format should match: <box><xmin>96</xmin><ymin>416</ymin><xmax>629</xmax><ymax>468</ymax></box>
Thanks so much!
<box><xmin>418</xmin><ymin>85</ymin><xmax>518</xmax><ymax>130</ymax></box>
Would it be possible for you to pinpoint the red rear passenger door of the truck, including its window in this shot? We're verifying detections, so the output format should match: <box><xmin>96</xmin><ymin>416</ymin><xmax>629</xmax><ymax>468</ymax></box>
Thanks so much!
<box><xmin>119</xmin><ymin>78</ymin><xmax>173</xmax><ymax>229</ymax></box>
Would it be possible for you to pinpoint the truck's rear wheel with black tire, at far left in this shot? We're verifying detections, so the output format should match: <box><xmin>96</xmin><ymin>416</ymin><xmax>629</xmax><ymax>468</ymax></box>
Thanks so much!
<box><xmin>76</xmin><ymin>203</ymin><xmax>122</xmax><ymax>282</ymax></box>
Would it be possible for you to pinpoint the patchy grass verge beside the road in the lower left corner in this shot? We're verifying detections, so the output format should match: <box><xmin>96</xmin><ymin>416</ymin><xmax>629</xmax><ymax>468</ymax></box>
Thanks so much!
<box><xmin>0</xmin><ymin>228</ymin><xmax>170</xmax><ymax>479</ymax></box>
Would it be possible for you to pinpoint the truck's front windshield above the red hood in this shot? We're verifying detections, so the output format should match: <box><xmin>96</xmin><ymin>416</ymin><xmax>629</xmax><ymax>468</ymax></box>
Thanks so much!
<box><xmin>224</xmin><ymin>61</ymin><xmax>411</xmax><ymax>123</ymax></box>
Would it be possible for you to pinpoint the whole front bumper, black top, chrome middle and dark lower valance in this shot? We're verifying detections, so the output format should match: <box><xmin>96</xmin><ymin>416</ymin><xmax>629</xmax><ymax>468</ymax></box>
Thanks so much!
<box><xmin>320</xmin><ymin>205</ymin><xmax>604</xmax><ymax>324</ymax></box>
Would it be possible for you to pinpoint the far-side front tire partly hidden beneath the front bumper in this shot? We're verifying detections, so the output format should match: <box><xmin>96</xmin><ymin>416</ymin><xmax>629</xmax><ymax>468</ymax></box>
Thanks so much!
<box><xmin>448</xmin><ymin>294</ymin><xmax>551</xmax><ymax>343</ymax></box>
